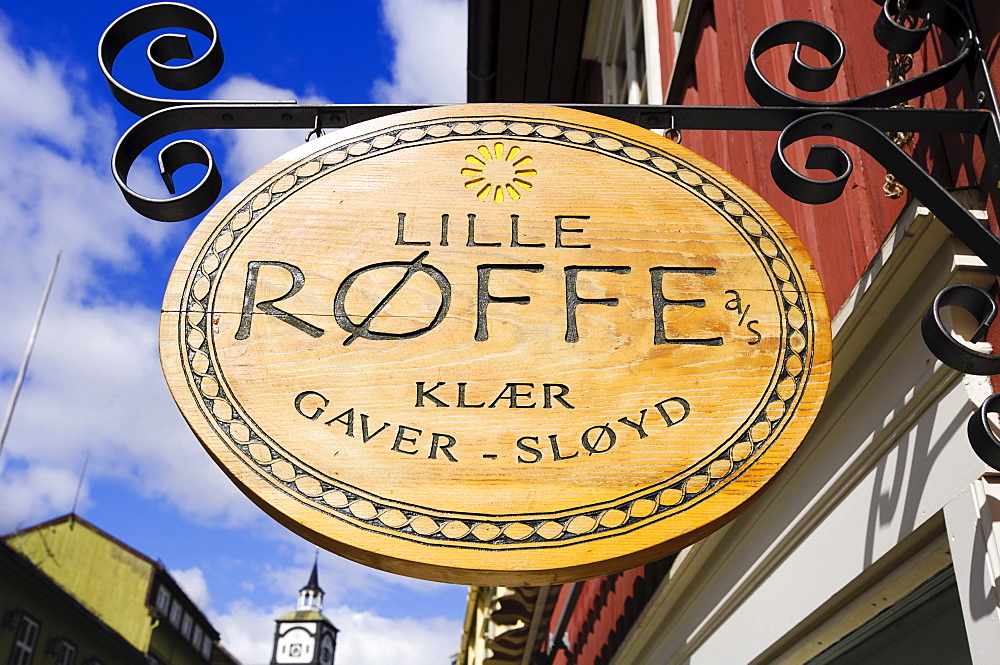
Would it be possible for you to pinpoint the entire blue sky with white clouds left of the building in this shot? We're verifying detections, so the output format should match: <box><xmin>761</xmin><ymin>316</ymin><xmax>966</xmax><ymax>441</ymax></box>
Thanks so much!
<box><xmin>0</xmin><ymin>0</ymin><xmax>466</xmax><ymax>665</ymax></box>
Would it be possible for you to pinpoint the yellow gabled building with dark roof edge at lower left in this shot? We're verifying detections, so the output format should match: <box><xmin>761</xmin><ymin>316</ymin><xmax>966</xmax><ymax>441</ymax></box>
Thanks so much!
<box><xmin>4</xmin><ymin>514</ymin><xmax>235</xmax><ymax>665</ymax></box>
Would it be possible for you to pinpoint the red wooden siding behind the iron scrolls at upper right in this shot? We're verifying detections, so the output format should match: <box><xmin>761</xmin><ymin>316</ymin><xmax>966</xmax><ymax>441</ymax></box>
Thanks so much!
<box><xmin>665</xmin><ymin>0</ymin><xmax>996</xmax><ymax>314</ymax></box>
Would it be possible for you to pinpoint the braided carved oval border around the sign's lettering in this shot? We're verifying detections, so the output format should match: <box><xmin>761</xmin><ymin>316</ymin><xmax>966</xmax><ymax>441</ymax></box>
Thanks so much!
<box><xmin>178</xmin><ymin>117</ymin><xmax>814</xmax><ymax>549</ymax></box>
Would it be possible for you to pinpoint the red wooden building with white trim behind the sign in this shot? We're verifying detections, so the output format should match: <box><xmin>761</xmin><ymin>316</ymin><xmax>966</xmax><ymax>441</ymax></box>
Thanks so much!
<box><xmin>459</xmin><ymin>0</ymin><xmax>1000</xmax><ymax>665</ymax></box>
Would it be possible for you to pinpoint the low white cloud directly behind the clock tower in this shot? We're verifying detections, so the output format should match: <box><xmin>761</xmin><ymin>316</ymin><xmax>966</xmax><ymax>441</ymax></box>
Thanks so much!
<box><xmin>209</xmin><ymin>600</ymin><xmax>462</xmax><ymax>665</ymax></box>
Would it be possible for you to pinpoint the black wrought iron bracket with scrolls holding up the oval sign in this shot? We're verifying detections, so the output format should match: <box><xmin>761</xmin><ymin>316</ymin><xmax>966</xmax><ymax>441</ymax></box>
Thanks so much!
<box><xmin>98</xmin><ymin>0</ymin><xmax>1000</xmax><ymax>470</ymax></box>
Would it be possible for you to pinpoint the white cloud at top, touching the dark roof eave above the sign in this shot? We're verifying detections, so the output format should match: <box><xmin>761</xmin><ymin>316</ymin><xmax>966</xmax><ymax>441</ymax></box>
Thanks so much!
<box><xmin>372</xmin><ymin>0</ymin><xmax>468</xmax><ymax>104</ymax></box>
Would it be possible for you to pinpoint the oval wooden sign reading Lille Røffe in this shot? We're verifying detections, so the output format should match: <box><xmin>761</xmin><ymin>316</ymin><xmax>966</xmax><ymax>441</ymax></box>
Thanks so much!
<box><xmin>161</xmin><ymin>105</ymin><xmax>830</xmax><ymax>585</ymax></box>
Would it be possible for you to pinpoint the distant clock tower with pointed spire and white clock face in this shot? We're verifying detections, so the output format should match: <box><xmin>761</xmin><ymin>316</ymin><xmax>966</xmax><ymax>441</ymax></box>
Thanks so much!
<box><xmin>271</xmin><ymin>561</ymin><xmax>338</xmax><ymax>665</ymax></box>
